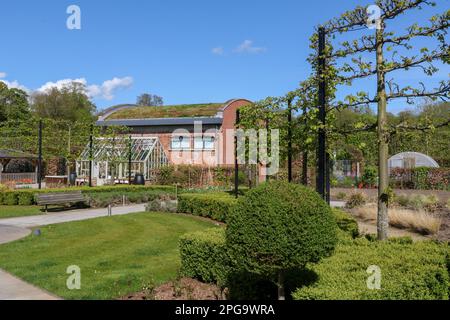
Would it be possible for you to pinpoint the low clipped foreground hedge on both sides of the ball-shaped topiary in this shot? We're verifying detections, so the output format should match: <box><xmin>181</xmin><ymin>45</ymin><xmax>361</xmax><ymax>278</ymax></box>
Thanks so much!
<box><xmin>180</xmin><ymin>228</ymin><xmax>450</xmax><ymax>300</ymax></box>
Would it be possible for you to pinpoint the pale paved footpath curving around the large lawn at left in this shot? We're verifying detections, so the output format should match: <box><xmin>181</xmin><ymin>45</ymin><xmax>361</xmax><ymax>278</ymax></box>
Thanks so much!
<box><xmin>0</xmin><ymin>204</ymin><xmax>145</xmax><ymax>300</ymax></box>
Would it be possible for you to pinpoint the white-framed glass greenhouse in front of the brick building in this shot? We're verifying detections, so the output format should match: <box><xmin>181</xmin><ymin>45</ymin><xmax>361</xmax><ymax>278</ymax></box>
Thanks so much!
<box><xmin>76</xmin><ymin>137</ymin><xmax>168</xmax><ymax>185</ymax></box>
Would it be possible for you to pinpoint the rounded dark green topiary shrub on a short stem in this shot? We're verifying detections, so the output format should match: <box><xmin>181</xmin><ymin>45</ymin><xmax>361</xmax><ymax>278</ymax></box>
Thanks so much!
<box><xmin>226</xmin><ymin>181</ymin><xmax>337</xmax><ymax>299</ymax></box>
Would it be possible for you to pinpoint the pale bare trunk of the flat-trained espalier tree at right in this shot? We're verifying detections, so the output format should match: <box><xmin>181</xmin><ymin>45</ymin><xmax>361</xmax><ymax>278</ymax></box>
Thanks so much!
<box><xmin>376</xmin><ymin>22</ymin><xmax>389</xmax><ymax>240</ymax></box>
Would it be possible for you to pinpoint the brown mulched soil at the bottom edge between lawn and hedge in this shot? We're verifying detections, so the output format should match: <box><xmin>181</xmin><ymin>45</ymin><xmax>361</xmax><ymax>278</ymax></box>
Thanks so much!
<box><xmin>120</xmin><ymin>278</ymin><xmax>224</xmax><ymax>300</ymax></box>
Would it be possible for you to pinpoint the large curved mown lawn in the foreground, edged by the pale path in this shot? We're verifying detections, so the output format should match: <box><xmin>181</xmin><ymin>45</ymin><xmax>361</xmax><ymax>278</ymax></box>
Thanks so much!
<box><xmin>0</xmin><ymin>213</ymin><xmax>218</xmax><ymax>299</ymax></box>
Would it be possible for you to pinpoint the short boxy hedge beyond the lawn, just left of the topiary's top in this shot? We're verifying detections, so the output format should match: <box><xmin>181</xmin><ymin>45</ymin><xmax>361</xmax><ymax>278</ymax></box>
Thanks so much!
<box><xmin>177</xmin><ymin>192</ymin><xmax>237</xmax><ymax>222</ymax></box>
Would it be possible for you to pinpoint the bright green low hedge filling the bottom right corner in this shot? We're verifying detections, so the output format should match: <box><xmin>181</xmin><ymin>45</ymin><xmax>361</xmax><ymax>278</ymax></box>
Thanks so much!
<box><xmin>292</xmin><ymin>238</ymin><xmax>450</xmax><ymax>300</ymax></box>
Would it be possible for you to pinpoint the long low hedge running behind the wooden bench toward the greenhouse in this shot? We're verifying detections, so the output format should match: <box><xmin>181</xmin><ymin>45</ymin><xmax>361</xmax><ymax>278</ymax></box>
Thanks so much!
<box><xmin>0</xmin><ymin>185</ymin><xmax>175</xmax><ymax>206</ymax></box>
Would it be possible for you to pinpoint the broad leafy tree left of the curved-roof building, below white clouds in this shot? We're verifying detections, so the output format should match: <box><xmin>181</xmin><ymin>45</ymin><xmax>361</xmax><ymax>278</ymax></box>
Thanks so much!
<box><xmin>31</xmin><ymin>82</ymin><xmax>96</xmax><ymax>121</ymax></box>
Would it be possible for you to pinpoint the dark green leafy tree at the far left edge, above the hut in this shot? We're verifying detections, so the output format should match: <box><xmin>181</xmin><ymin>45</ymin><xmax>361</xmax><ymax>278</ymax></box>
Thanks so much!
<box><xmin>0</xmin><ymin>81</ymin><xmax>30</xmax><ymax>122</ymax></box>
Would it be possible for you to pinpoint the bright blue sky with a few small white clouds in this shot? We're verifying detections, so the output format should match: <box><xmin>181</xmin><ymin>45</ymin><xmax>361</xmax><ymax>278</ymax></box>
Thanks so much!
<box><xmin>0</xmin><ymin>0</ymin><xmax>450</xmax><ymax>112</ymax></box>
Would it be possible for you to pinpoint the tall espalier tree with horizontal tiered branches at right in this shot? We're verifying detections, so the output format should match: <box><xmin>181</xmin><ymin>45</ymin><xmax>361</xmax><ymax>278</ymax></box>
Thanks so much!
<box><xmin>325</xmin><ymin>0</ymin><xmax>450</xmax><ymax>240</ymax></box>
